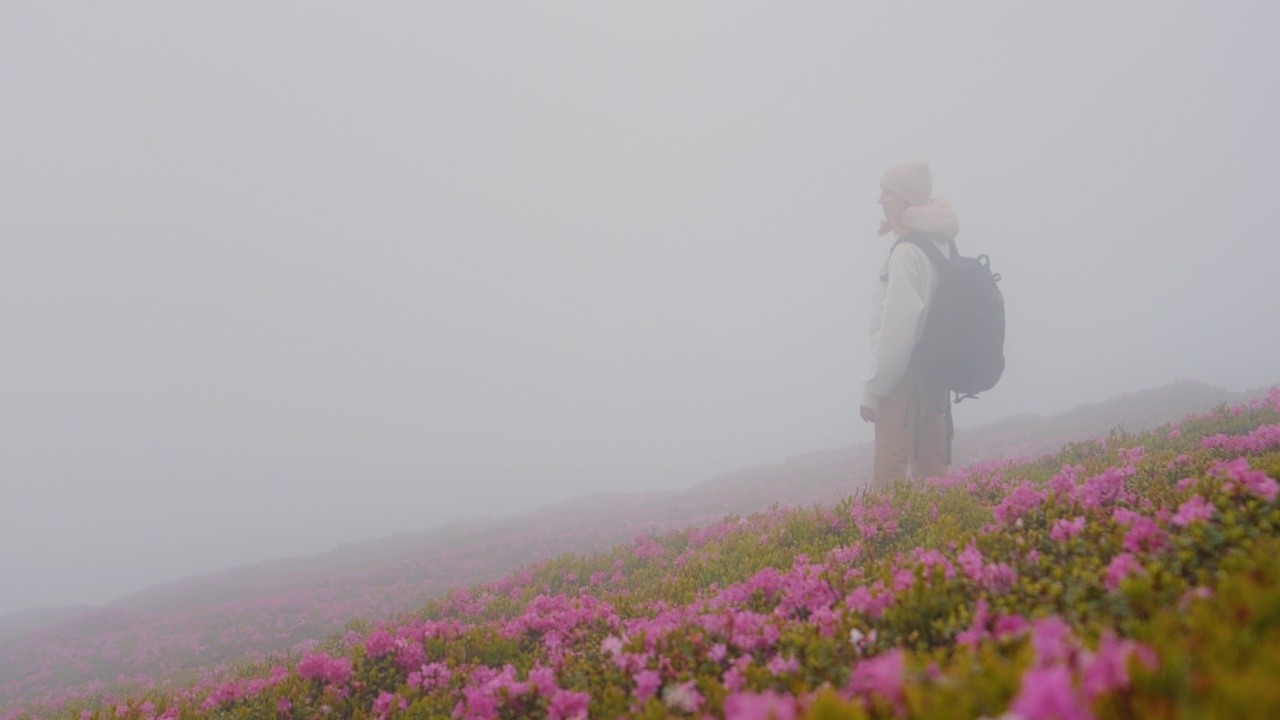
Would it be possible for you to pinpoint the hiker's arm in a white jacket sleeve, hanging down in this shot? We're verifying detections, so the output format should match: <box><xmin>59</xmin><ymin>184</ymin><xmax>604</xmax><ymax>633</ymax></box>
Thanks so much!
<box><xmin>861</xmin><ymin>243</ymin><xmax>929</xmax><ymax>412</ymax></box>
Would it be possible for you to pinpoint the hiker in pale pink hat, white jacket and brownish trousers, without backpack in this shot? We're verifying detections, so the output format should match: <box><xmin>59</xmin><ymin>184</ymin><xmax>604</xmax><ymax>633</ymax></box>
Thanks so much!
<box><xmin>860</xmin><ymin>161</ymin><xmax>960</xmax><ymax>489</ymax></box>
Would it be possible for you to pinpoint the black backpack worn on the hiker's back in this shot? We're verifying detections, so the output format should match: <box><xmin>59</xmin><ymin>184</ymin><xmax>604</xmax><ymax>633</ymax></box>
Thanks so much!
<box><xmin>893</xmin><ymin>233</ymin><xmax>1005</xmax><ymax>402</ymax></box>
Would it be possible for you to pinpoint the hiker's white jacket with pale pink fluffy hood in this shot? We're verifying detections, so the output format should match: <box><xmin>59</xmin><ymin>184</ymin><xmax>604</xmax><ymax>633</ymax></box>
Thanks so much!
<box><xmin>863</xmin><ymin>197</ymin><xmax>960</xmax><ymax>410</ymax></box>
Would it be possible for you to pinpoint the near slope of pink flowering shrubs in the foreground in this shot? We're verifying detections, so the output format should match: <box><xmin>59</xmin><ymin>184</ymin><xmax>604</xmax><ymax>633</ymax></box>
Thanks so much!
<box><xmin>6</xmin><ymin>389</ymin><xmax>1280</xmax><ymax>720</ymax></box>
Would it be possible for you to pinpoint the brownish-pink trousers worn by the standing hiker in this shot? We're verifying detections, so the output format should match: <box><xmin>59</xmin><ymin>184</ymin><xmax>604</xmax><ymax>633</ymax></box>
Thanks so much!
<box><xmin>872</xmin><ymin>369</ymin><xmax>951</xmax><ymax>489</ymax></box>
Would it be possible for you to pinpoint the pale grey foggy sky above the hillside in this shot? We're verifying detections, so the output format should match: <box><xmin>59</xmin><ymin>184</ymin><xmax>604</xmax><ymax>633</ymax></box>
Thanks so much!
<box><xmin>0</xmin><ymin>1</ymin><xmax>1280</xmax><ymax>611</ymax></box>
